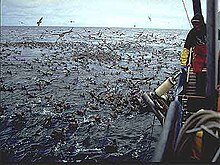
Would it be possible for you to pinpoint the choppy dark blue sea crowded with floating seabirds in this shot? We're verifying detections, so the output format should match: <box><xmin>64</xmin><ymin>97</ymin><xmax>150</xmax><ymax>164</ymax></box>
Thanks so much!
<box><xmin>0</xmin><ymin>27</ymin><xmax>186</xmax><ymax>163</ymax></box>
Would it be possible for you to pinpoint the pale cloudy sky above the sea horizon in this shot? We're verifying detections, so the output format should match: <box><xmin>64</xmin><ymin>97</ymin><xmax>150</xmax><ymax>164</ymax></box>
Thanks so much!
<box><xmin>1</xmin><ymin>0</ymin><xmax>206</xmax><ymax>29</ymax></box>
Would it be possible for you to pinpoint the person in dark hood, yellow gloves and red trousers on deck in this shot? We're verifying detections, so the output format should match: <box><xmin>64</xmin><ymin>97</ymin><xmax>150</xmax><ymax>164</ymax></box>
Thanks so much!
<box><xmin>180</xmin><ymin>13</ymin><xmax>207</xmax><ymax>96</ymax></box>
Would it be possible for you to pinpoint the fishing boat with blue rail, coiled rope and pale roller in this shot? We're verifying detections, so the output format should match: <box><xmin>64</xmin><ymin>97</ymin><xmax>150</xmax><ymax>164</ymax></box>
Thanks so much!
<box><xmin>143</xmin><ymin>0</ymin><xmax>220</xmax><ymax>162</ymax></box>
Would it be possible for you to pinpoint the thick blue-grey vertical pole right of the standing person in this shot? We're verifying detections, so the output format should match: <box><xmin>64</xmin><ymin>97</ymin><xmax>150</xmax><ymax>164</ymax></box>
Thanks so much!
<box><xmin>206</xmin><ymin>0</ymin><xmax>216</xmax><ymax>108</ymax></box>
